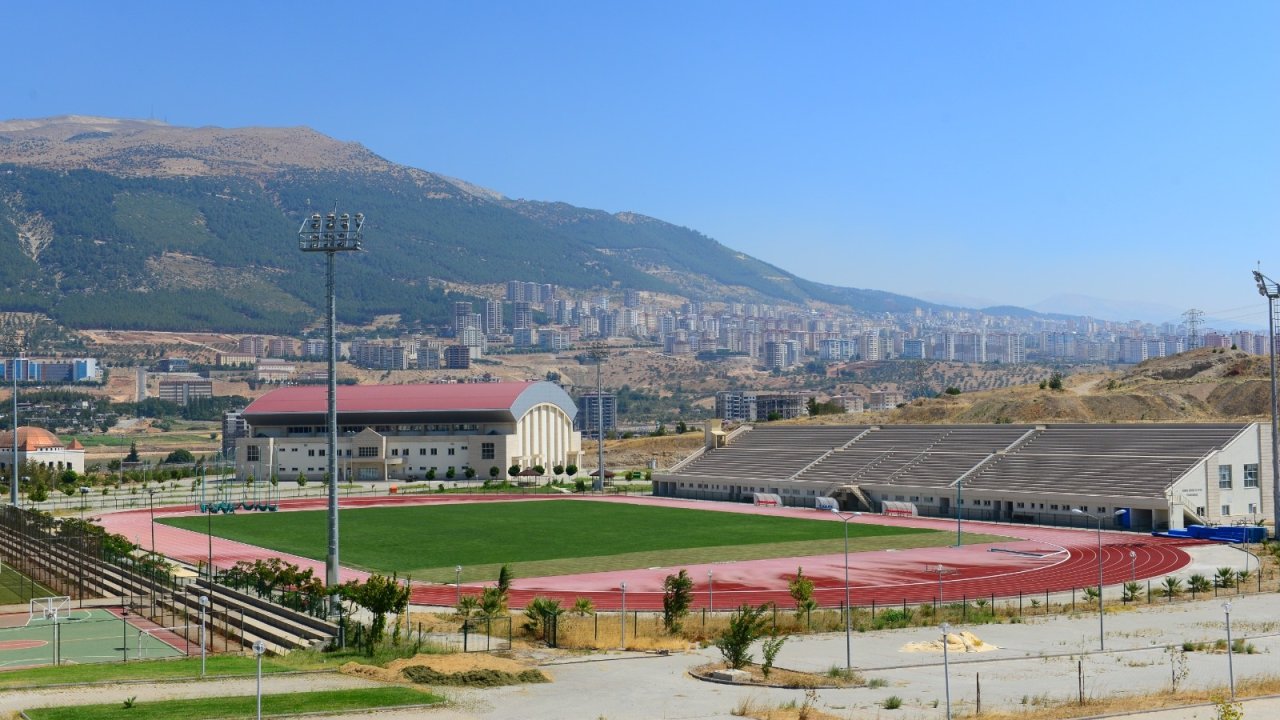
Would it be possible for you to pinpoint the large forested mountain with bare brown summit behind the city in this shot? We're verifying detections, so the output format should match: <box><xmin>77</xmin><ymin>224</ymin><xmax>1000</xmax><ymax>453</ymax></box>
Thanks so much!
<box><xmin>0</xmin><ymin>117</ymin><xmax>937</xmax><ymax>333</ymax></box>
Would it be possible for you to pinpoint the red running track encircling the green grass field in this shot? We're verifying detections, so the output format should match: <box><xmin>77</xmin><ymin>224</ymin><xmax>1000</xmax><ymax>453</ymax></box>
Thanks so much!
<box><xmin>102</xmin><ymin>496</ymin><xmax>1202</xmax><ymax>610</ymax></box>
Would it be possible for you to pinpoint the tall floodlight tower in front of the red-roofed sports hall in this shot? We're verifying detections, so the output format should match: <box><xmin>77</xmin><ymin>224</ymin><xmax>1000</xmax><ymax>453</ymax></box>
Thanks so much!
<box><xmin>298</xmin><ymin>210</ymin><xmax>365</xmax><ymax>587</ymax></box>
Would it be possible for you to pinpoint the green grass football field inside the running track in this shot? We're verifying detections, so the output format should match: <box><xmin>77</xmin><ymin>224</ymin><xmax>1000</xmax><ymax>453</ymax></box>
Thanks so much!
<box><xmin>161</xmin><ymin>500</ymin><xmax>1002</xmax><ymax>582</ymax></box>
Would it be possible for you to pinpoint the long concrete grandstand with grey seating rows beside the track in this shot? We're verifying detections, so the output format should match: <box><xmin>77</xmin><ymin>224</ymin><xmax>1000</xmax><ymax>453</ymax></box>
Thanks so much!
<box><xmin>654</xmin><ymin>423</ymin><xmax>1272</xmax><ymax>530</ymax></box>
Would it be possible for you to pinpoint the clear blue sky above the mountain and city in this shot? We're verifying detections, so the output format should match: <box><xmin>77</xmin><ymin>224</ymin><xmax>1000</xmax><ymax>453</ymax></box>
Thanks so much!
<box><xmin>0</xmin><ymin>1</ymin><xmax>1280</xmax><ymax>327</ymax></box>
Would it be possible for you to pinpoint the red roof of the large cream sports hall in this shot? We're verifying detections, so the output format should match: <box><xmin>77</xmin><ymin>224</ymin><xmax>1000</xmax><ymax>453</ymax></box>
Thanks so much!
<box><xmin>243</xmin><ymin>382</ymin><xmax>534</xmax><ymax>415</ymax></box>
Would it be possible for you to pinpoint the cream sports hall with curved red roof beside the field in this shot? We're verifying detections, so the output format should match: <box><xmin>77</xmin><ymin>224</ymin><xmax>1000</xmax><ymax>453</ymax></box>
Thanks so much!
<box><xmin>236</xmin><ymin>382</ymin><xmax>582</xmax><ymax>482</ymax></box>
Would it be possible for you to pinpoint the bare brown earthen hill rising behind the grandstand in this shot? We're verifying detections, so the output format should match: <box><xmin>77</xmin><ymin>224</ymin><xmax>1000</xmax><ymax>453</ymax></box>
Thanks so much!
<box><xmin>886</xmin><ymin>348</ymin><xmax>1271</xmax><ymax>423</ymax></box>
